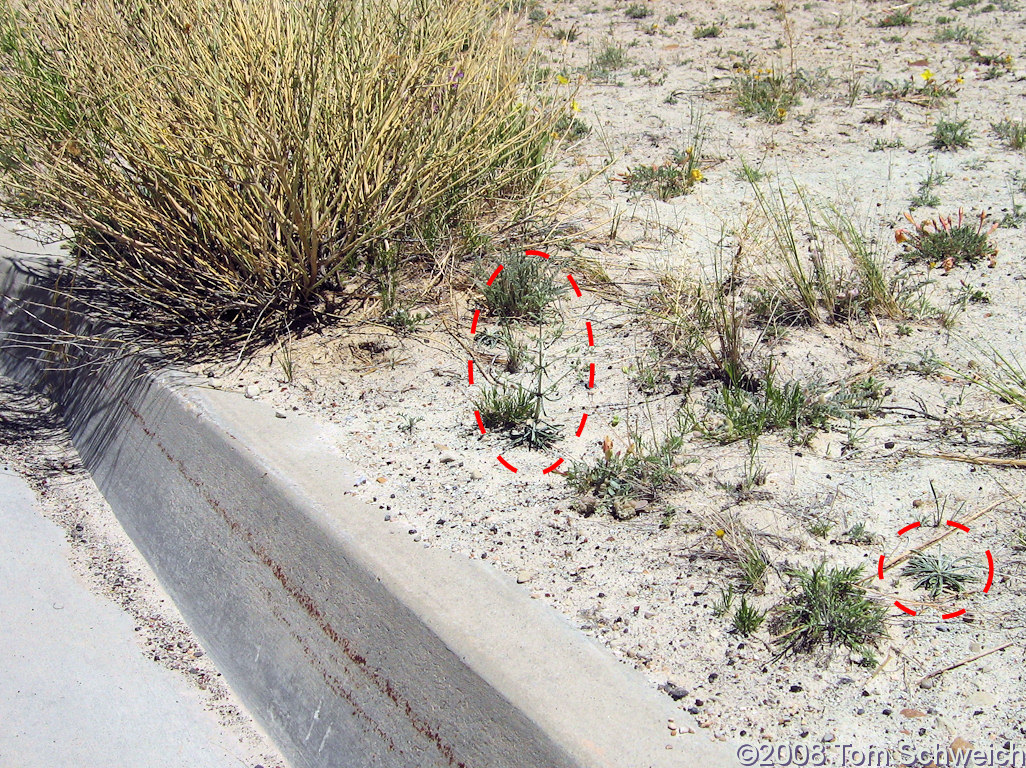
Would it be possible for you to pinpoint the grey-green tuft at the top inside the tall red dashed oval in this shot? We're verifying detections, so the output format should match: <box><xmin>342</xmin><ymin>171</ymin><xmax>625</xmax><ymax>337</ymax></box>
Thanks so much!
<box><xmin>479</xmin><ymin>251</ymin><xmax>568</xmax><ymax>323</ymax></box>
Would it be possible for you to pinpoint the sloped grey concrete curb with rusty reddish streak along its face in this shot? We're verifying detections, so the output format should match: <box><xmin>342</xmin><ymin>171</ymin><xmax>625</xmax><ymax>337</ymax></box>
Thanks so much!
<box><xmin>0</xmin><ymin>236</ymin><xmax>736</xmax><ymax>768</ymax></box>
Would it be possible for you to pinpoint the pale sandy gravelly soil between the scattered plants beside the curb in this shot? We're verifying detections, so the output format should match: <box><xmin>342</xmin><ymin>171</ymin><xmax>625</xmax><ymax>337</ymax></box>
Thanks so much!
<box><xmin>188</xmin><ymin>0</ymin><xmax>1026</xmax><ymax>747</ymax></box>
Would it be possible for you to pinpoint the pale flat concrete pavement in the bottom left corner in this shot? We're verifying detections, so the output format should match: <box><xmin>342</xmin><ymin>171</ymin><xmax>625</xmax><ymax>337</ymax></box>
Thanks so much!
<box><xmin>0</xmin><ymin>466</ymin><xmax>268</xmax><ymax>768</ymax></box>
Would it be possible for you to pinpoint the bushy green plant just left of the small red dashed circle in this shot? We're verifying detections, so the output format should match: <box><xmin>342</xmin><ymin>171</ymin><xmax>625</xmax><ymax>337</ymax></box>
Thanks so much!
<box><xmin>774</xmin><ymin>562</ymin><xmax>886</xmax><ymax>665</ymax></box>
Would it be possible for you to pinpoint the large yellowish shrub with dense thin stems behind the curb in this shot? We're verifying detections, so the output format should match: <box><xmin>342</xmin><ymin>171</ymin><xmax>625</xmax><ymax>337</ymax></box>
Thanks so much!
<box><xmin>0</xmin><ymin>0</ymin><xmax>565</xmax><ymax>338</ymax></box>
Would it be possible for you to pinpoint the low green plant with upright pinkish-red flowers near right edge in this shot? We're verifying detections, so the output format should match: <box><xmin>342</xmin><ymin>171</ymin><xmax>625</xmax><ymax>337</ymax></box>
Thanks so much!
<box><xmin>895</xmin><ymin>209</ymin><xmax>997</xmax><ymax>270</ymax></box>
